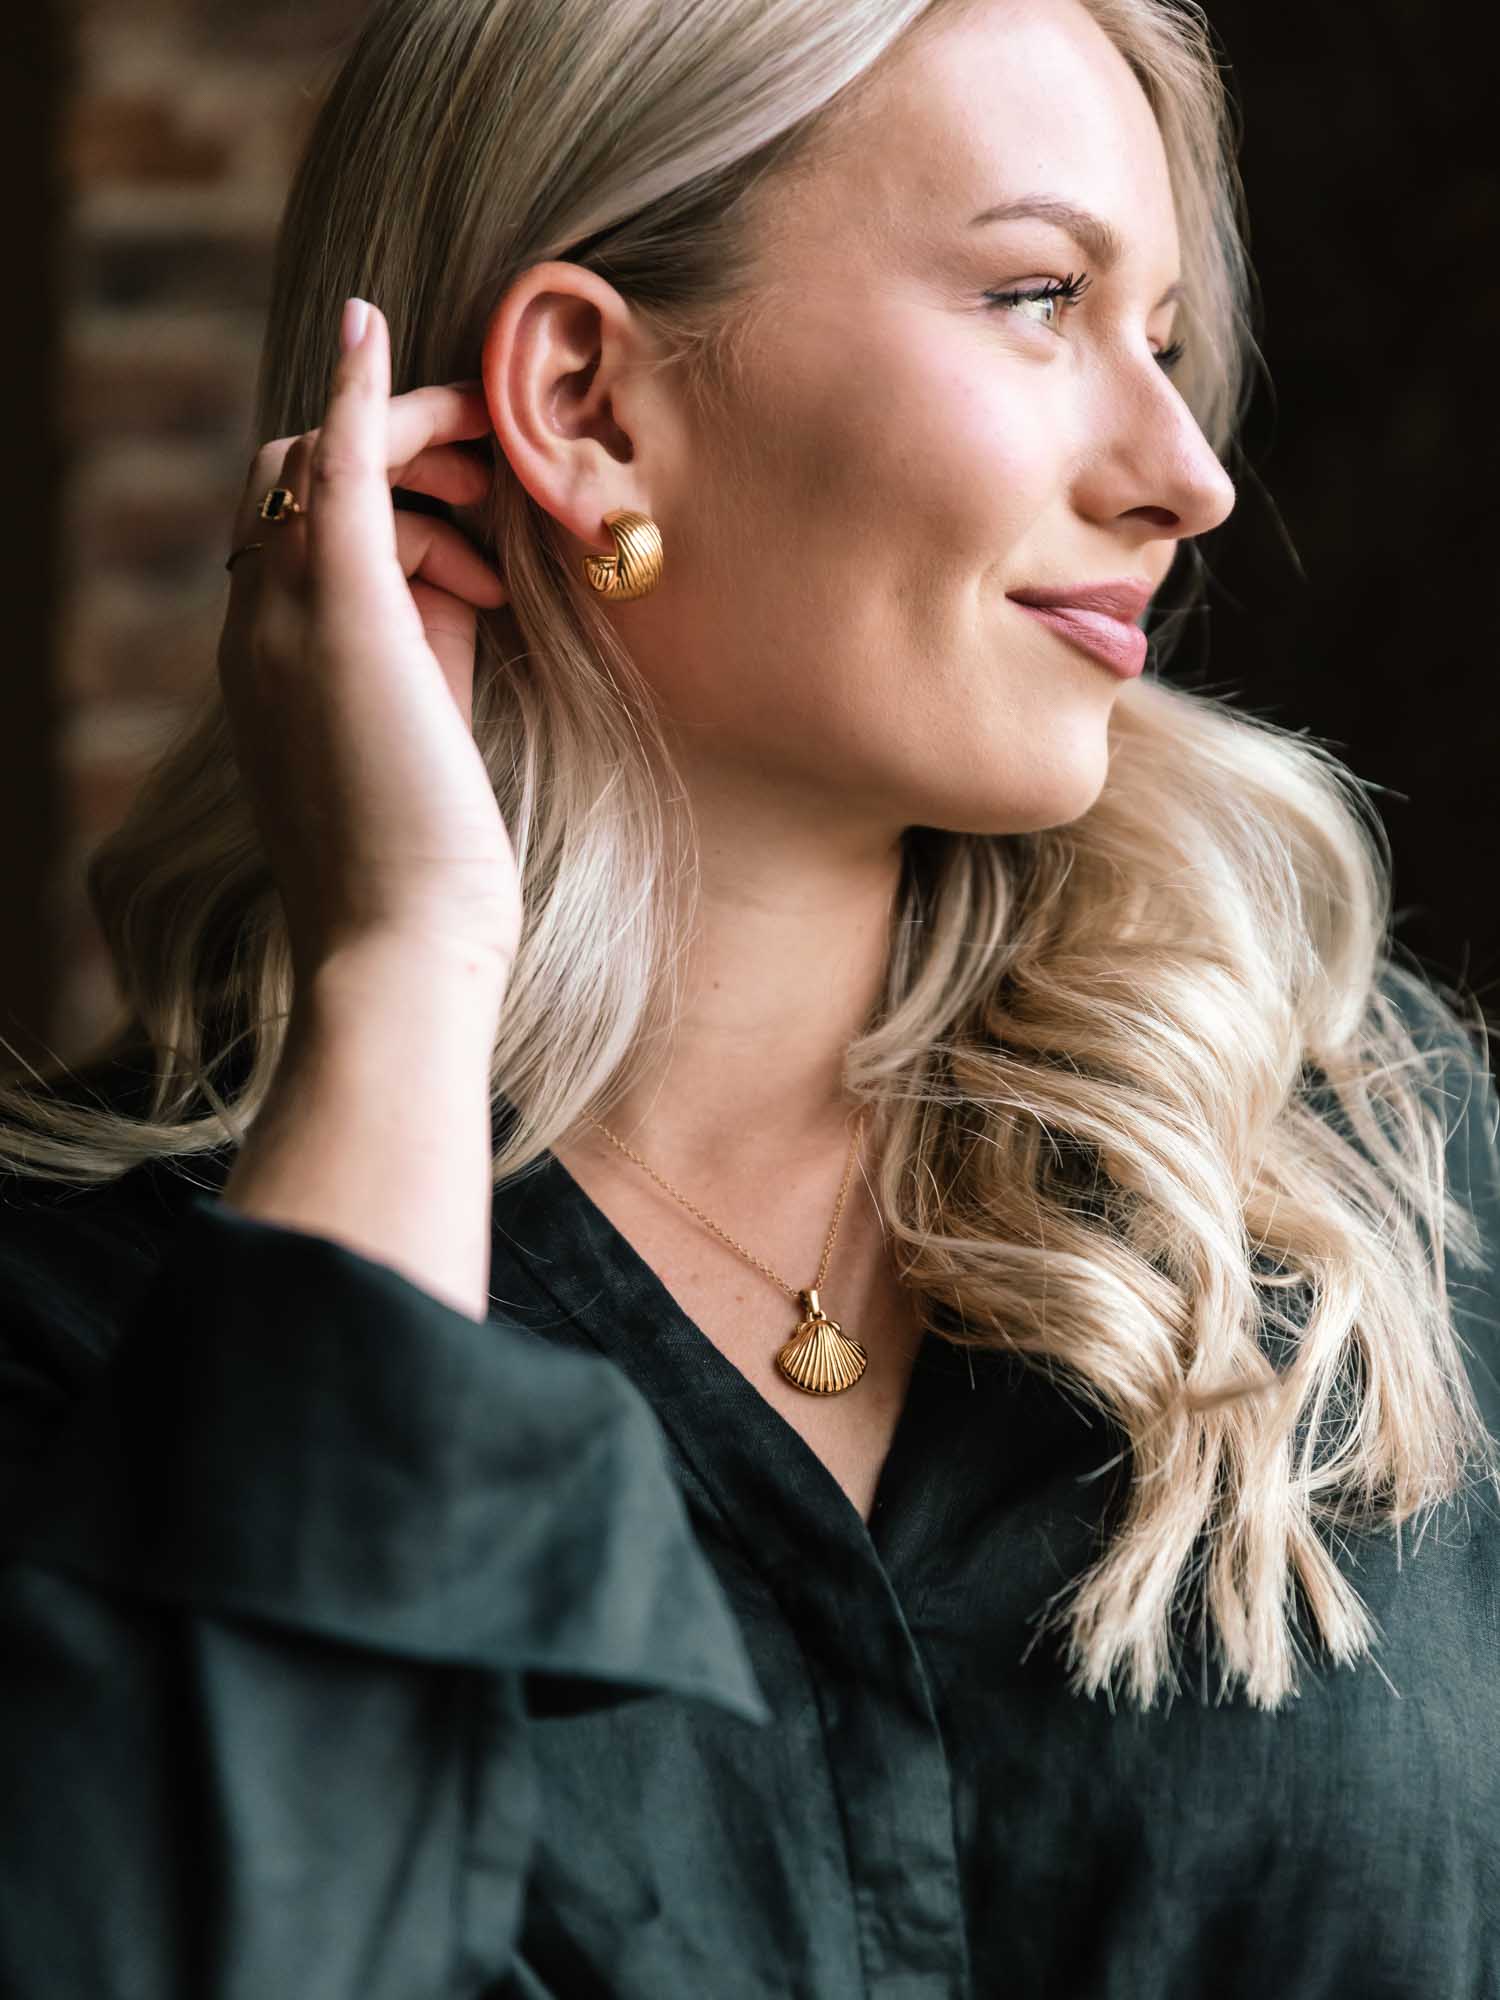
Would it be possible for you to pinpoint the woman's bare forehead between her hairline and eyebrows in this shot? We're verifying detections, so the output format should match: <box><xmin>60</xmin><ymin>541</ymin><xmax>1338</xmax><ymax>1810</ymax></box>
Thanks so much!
<box><xmin>780</xmin><ymin>0</ymin><xmax>1178</xmax><ymax>276</ymax></box>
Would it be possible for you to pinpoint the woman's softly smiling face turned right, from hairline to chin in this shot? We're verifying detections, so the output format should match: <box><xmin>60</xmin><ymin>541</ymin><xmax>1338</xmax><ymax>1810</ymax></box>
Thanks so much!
<box><xmin>500</xmin><ymin>0</ymin><xmax>1234</xmax><ymax>840</ymax></box>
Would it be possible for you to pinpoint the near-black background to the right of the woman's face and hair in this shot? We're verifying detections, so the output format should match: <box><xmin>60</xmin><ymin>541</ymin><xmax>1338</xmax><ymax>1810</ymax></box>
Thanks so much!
<box><xmin>1178</xmin><ymin>0</ymin><xmax>1500</xmax><ymax>1012</ymax></box>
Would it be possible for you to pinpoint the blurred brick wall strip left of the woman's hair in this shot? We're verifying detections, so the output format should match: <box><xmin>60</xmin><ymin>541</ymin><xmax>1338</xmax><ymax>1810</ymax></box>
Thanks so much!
<box><xmin>50</xmin><ymin>0</ymin><xmax>364</xmax><ymax>1060</ymax></box>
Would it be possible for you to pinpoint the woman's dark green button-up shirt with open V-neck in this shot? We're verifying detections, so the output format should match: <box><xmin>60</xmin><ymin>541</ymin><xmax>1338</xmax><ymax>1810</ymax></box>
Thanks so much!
<box><xmin>0</xmin><ymin>960</ymin><xmax>1500</xmax><ymax>2000</ymax></box>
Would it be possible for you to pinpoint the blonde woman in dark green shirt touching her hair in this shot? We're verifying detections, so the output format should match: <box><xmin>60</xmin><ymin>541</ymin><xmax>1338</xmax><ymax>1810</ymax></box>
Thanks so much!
<box><xmin>0</xmin><ymin>0</ymin><xmax>1500</xmax><ymax>2000</ymax></box>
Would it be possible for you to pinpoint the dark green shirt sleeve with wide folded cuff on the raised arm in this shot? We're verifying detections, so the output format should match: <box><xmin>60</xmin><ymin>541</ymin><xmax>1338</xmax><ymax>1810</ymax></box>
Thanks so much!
<box><xmin>0</xmin><ymin>1196</ymin><xmax>770</xmax><ymax>2000</ymax></box>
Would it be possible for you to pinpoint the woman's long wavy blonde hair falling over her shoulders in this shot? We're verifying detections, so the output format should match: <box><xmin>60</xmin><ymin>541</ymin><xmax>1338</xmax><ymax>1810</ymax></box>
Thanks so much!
<box><xmin>0</xmin><ymin>0</ymin><xmax>1500</xmax><ymax>1708</ymax></box>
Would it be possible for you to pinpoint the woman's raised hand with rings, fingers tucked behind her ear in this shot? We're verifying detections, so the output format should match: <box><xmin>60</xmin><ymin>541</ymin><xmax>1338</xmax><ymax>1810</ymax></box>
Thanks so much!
<box><xmin>218</xmin><ymin>300</ymin><xmax>520</xmax><ymax>998</ymax></box>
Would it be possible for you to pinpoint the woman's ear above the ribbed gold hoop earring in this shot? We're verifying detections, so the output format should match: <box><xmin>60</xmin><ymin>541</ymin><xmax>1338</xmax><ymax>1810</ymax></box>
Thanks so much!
<box><xmin>480</xmin><ymin>262</ymin><xmax>672</xmax><ymax>564</ymax></box>
